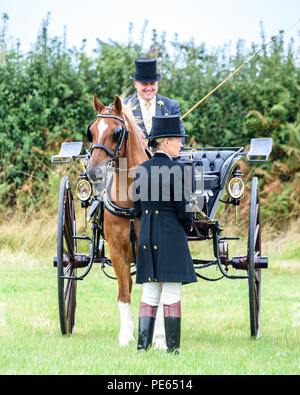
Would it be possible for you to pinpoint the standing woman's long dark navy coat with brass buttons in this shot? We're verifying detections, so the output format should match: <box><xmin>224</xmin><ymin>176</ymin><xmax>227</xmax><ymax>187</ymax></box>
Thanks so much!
<box><xmin>134</xmin><ymin>153</ymin><xmax>197</xmax><ymax>284</ymax></box>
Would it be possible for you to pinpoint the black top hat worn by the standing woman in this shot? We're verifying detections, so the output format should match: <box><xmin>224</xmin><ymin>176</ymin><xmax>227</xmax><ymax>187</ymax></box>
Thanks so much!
<box><xmin>146</xmin><ymin>115</ymin><xmax>188</xmax><ymax>140</ymax></box>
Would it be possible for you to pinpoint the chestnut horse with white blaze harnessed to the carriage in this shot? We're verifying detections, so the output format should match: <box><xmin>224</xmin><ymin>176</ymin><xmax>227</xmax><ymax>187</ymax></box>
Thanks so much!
<box><xmin>87</xmin><ymin>95</ymin><xmax>163</xmax><ymax>346</ymax></box>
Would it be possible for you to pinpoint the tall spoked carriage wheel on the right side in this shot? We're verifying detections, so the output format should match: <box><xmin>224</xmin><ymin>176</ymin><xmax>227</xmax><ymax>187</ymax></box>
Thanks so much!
<box><xmin>247</xmin><ymin>177</ymin><xmax>261</xmax><ymax>339</ymax></box>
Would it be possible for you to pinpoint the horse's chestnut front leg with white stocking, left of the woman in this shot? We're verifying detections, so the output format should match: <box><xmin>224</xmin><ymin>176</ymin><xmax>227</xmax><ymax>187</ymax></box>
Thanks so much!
<box><xmin>112</xmin><ymin>256</ymin><xmax>135</xmax><ymax>346</ymax></box>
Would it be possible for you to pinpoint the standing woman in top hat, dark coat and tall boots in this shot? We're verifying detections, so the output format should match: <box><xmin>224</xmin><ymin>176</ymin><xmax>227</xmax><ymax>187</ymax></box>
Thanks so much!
<box><xmin>134</xmin><ymin>116</ymin><xmax>197</xmax><ymax>353</ymax></box>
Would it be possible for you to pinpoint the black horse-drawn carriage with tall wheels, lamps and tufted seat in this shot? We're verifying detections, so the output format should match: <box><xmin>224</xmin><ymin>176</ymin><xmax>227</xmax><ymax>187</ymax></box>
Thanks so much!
<box><xmin>51</xmin><ymin>138</ymin><xmax>272</xmax><ymax>338</ymax></box>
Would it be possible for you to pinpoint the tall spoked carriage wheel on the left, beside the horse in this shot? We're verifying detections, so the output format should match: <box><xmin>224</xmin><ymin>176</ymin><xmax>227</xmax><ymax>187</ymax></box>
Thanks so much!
<box><xmin>57</xmin><ymin>177</ymin><xmax>77</xmax><ymax>335</ymax></box>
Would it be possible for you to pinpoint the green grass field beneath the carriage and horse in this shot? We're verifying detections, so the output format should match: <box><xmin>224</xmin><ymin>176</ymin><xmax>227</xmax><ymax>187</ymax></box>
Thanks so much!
<box><xmin>0</xmin><ymin>215</ymin><xmax>300</xmax><ymax>375</ymax></box>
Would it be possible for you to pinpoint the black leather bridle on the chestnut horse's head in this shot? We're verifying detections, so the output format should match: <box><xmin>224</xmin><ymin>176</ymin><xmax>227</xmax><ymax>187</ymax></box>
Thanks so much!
<box><xmin>86</xmin><ymin>107</ymin><xmax>128</xmax><ymax>165</ymax></box>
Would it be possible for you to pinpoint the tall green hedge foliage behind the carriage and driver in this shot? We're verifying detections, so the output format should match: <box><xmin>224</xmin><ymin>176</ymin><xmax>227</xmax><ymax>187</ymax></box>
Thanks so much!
<box><xmin>0</xmin><ymin>14</ymin><xmax>300</xmax><ymax>229</ymax></box>
